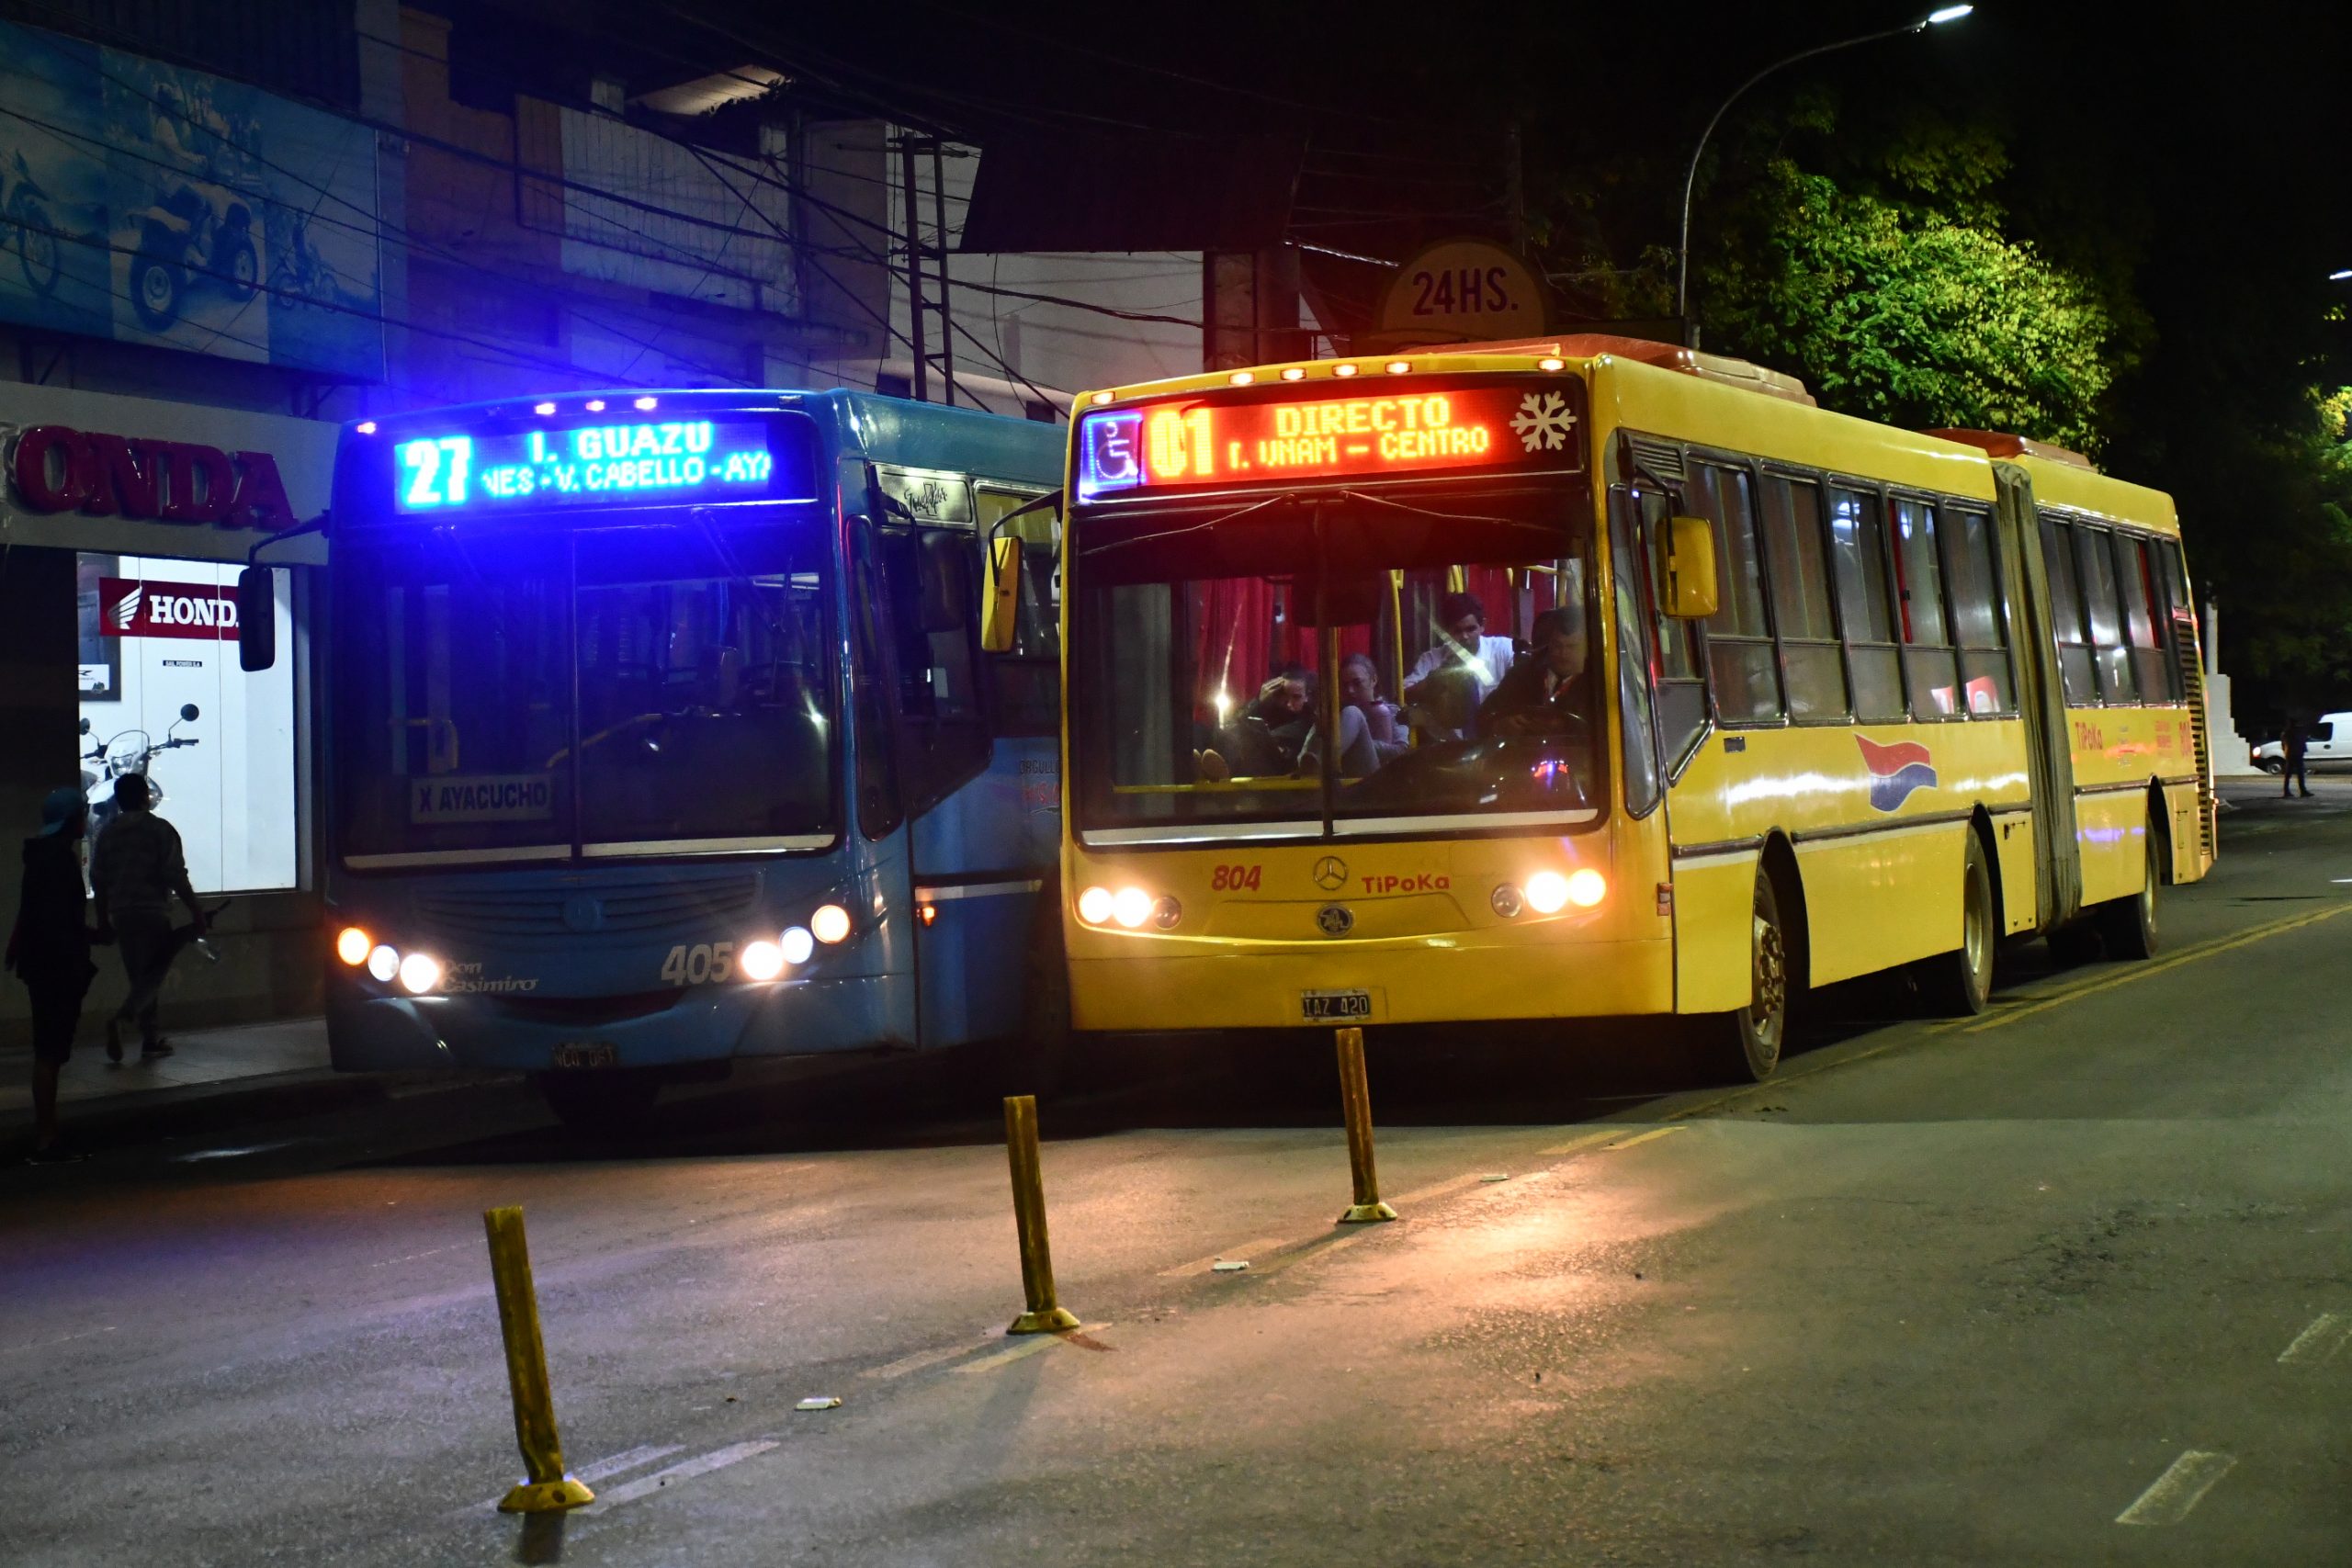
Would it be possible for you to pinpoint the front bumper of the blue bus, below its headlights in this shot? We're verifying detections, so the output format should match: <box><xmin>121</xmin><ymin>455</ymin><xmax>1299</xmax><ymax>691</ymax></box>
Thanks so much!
<box><xmin>327</xmin><ymin>976</ymin><xmax>915</xmax><ymax>1072</ymax></box>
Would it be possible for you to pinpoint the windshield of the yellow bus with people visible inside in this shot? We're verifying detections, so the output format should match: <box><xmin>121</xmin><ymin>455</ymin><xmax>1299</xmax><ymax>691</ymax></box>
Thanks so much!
<box><xmin>1070</xmin><ymin>484</ymin><xmax>1606</xmax><ymax>841</ymax></box>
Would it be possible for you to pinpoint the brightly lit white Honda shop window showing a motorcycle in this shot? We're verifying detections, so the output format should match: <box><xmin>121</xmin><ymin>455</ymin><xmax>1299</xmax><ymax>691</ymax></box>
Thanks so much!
<box><xmin>77</xmin><ymin>552</ymin><xmax>299</xmax><ymax>894</ymax></box>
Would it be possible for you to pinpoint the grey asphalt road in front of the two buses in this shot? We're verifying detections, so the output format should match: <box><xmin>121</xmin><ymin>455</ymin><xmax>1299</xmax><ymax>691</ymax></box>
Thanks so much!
<box><xmin>0</xmin><ymin>781</ymin><xmax>2352</xmax><ymax>1565</ymax></box>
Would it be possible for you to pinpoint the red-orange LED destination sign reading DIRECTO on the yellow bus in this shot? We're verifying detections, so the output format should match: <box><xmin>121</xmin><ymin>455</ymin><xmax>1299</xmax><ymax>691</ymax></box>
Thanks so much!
<box><xmin>1077</xmin><ymin>381</ymin><xmax>1583</xmax><ymax>499</ymax></box>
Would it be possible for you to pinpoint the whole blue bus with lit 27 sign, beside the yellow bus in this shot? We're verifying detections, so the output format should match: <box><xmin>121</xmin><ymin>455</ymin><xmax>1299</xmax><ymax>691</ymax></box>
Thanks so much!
<box><xmin>244</xmin><ymin>390</ymin><xmax>1063</xmax><ymax>1126</ymax></box>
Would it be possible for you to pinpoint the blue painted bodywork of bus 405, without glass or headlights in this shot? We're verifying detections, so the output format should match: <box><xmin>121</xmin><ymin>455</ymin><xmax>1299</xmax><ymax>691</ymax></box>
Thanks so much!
<box><xmin>327</xmin><ymin>390</ymin><xmax>1061</xmax><ymax>1072</ymax></box>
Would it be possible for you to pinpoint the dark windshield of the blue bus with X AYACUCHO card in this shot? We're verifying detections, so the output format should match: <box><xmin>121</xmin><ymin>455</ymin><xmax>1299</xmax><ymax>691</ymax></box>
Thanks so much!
<box><xmin>336</xmin><ymin>513</ymin><xmax>837</xmax><ymax>865</ymax></box>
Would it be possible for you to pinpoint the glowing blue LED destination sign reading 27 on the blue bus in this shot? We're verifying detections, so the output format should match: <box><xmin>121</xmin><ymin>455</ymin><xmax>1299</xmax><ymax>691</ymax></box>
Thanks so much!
<box><xmin>393</xmin><ymin>419</ymin><xmax>790</xmax><ymax>513</ymax></box>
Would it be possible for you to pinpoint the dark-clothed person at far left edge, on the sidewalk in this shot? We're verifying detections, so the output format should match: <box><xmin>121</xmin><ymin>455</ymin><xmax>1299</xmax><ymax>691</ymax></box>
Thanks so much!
<box><xmin>7</xmin><ymin>785</ymin><xmax>99</xmax><ymax>1164</ymax></box>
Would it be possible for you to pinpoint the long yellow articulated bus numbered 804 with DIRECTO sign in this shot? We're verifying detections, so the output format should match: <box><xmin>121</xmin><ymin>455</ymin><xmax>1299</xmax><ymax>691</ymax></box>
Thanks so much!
<box><xmin>992</xmin><ymin>336</ymin><xmax>2213</xmax><ymax>1077</ymax></box>
